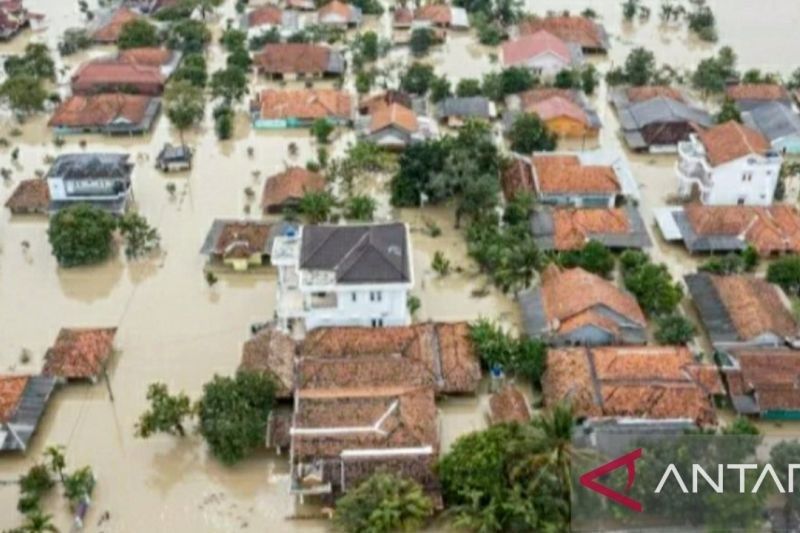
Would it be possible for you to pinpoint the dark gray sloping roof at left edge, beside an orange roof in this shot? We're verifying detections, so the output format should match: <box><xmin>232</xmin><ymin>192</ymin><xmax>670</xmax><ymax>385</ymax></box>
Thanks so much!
<box><xmin>0</xmin><ymin>376</ymin><xmax>56</xmax><ymax>451</ymax></box>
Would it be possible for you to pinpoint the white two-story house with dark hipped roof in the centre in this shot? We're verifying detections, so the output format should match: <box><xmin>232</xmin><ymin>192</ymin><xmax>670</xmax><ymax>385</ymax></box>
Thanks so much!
<box><xmin>271</xmin><ymin>223</ymin><xmax>414</xmax><ymax>336</ymax></box>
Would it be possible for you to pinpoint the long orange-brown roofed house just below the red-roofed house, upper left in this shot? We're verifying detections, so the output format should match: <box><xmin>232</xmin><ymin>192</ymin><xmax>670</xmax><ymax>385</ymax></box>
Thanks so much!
<box><xmin>48</xmin><ymin>93</ymin><xmax>161</xmax><ymax>135</ymax></box>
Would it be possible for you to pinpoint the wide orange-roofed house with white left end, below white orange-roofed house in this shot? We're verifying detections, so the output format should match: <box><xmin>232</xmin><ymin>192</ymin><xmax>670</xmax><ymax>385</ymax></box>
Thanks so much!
<box><xmin>655</xmin><ymin>204</ymin><xmax>800</xmax><ymax>257</ymax></box>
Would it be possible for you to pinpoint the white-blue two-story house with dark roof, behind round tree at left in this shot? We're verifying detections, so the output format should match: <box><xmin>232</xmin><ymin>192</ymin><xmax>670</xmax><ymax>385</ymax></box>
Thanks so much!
<box><xmin>47</xmin><ymin>153</ymin><xmax>133</xmax><ymax>215</ymax></box>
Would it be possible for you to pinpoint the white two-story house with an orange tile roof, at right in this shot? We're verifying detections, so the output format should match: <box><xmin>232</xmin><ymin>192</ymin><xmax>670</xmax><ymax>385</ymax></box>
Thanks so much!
<box><xmin>675</xmin><ymin>121</ymin><xmax>782</xmax><ymax>205</ymax></box>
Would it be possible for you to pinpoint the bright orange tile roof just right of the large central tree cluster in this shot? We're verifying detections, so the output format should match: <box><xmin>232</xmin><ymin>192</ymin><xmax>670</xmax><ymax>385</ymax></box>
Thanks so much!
<box><xmin>532</xmin><ymin>154</ymin><xmax>622</xmax><ymax>194</ymax></box>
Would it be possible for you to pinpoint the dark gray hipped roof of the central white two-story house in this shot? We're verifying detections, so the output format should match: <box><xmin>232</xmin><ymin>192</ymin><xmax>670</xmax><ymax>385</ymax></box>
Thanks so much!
<box><xmin>300</xmin><ymin>223</ymin><xmax>411</xmax><ymax>283</ymax></box>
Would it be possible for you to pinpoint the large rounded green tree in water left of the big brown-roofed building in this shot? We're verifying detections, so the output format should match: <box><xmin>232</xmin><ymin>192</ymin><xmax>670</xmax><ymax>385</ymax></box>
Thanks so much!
<box><xmin>197</xmin><ymin>372</ymin><xmax>275</xmax><ymax>464</ymax></box>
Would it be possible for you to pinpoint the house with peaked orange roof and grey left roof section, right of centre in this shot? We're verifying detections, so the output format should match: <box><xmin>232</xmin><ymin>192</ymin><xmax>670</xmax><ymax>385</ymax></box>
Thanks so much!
<box><xmin>519</xmin><ymin>265</ymin><xmax>647</xmax><ymax>346</ymax></box>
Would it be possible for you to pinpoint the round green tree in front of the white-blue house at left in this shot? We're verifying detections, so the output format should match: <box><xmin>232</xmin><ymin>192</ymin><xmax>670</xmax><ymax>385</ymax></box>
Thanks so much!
<box><xmin>47</xmin><ymin>204</ymin><xmax>116</xmax><ymax>267</ymax></box>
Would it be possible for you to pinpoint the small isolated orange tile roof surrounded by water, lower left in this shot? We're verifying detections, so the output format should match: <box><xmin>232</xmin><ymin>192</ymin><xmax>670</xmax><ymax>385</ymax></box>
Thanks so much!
<box><xmin>42</xmin><ymin>328</ymin><xmax>117</xmax><ymax>379</ymax></box>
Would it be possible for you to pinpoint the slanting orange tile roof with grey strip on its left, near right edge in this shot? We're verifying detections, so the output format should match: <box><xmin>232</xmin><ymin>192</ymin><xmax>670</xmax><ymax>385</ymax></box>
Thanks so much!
<box><xmin>710</xmin><ymin>276</ymin><xmax>797</xmax><ymax>341</ymax></box>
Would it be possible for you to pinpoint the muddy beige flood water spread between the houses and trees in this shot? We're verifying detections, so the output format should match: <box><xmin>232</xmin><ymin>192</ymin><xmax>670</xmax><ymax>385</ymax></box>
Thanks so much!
<box><xmin>0</xmin><ymin>0</ymin><xmax>800</xmax><ymax>532</ymax></box>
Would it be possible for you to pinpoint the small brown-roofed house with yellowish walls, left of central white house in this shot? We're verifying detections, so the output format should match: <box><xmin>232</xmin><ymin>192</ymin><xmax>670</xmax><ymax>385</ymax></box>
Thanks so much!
<box><xmin>200</xmin><ymin>219</ymin><xmax>285</xmax><ymax>272</ymax></box>
